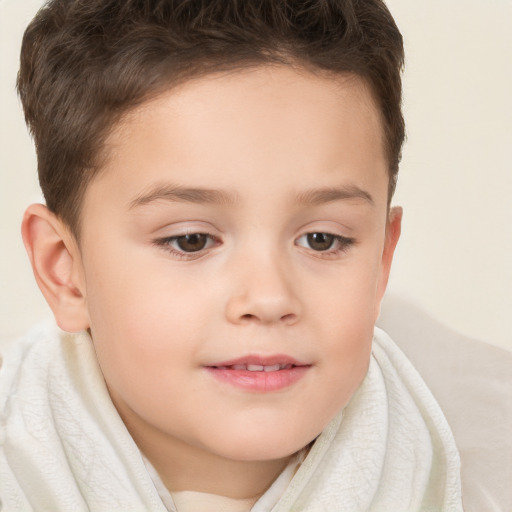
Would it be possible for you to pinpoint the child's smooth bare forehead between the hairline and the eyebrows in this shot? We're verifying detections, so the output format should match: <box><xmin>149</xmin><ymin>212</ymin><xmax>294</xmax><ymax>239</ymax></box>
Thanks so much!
<box><xmin>93</xmin><ymin>66</ymin><xmax>387</xmax><ymax>211</ymax></box>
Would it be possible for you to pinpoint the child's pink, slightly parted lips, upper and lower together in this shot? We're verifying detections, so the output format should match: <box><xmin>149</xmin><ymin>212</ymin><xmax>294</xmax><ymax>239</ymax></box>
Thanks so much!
<box><xmin>204</xmin><ymin>354</ymin><xmax>311</xmax><ymax>393</ymax></box>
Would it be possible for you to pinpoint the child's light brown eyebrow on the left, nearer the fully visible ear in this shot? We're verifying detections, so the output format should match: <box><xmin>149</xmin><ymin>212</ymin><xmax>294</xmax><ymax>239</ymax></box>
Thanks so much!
<box><xmin>130</xmin><ymin>185</ymin><xmax>236</xmax><ymax>209</ymax></box>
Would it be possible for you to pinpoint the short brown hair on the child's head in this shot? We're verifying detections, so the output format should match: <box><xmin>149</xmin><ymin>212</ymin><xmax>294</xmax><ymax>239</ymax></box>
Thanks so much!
<box><xmin>18</xmin><ymin>0</ymin><xmax>404</xmax><ymax>236</ymax></box>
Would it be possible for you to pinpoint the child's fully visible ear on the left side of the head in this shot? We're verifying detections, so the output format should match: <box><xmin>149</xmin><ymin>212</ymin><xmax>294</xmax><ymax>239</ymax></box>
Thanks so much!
<box><xmin>21</xmin><ymin>204</ymin><xmax>89</xmax><ymax>332</ymax></box>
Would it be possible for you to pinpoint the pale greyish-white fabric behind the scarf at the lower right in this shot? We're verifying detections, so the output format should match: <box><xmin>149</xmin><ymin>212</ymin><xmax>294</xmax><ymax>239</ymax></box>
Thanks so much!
<box><xmin>379</xmin><ymin>299</ymin><xmax>512</xmax><ymax>512</ymax></box>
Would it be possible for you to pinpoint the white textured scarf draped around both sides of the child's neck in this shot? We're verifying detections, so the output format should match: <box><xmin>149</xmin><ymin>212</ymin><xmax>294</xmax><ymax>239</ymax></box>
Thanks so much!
<box><xmin>0</xmin><ymin>328</ymin><xmax>462</xmax><ymax>512</ymax></box>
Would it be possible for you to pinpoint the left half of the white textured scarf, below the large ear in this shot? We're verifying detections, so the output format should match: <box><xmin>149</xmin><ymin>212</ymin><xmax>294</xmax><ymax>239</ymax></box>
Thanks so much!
<box><xmin>0</xmin><ymin>328</ymin><xmax>165</xmax><ymax>512</ymax></box>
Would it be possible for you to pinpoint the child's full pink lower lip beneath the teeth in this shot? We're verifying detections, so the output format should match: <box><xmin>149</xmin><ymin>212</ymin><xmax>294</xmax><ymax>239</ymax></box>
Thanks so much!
<box><xmin>206</xmin><ymin>366</ymin><xmax>311</xmax><ymax>393</ymax></box>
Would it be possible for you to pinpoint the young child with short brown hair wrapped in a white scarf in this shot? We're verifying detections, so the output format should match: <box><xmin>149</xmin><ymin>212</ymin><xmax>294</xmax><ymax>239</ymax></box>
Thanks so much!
<box><xmin>0</xmin><ymin>0</ymin><xmax>462</xmax><ymax>512</ymax></box>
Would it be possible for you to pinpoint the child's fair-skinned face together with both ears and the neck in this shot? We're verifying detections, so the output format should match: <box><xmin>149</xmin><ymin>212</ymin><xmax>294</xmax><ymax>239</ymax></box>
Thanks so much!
<box><xmin>23</xmin><ymin>66</ymin><xmax>401</xmax><ymax>498</ymax></box>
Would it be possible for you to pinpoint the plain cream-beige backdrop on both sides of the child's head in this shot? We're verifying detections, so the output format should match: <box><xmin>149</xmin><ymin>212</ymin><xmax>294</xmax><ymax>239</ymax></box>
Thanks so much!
<box><xmin>0</xmin><ymin>0</ymin><xmax>512</xmax><ymax>350</ymax></box>
